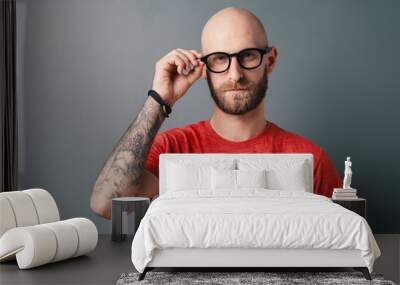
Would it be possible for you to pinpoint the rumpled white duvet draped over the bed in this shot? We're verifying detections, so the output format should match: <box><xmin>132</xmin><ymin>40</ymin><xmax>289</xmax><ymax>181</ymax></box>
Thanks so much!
<box><xmin>132</xmin><ymin>188</ymin><xmax>381</xmax><ymax>272</ymax></box>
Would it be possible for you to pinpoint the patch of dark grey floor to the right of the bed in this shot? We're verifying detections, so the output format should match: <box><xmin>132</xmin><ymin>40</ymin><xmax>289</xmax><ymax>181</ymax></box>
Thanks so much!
<box><xmin>374</xmin><ymin>234</ymin><xmax>400</xmax><ymax>284</ymax></box>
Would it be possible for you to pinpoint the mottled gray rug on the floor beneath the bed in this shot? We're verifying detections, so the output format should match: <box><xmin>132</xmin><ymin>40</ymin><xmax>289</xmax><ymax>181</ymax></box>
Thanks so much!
<box><xmin>117</xmin><ymin>271</ymin><xmax>395</xmax><ymax>285</ymax></box>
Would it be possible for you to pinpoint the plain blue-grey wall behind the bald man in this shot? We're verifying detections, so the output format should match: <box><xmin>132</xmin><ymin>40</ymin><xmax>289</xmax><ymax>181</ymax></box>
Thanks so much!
<box><xmin>17</xmin><ymin>0</ymin><xmax>400</xmax><ymax>233</ymax></box>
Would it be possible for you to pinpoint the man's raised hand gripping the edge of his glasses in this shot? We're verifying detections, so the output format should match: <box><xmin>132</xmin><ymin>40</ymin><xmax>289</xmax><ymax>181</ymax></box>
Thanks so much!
<box><xmin>152</xmin><ymin>48</ymin><xmax>204</xmax><ymax>106</ymax></box>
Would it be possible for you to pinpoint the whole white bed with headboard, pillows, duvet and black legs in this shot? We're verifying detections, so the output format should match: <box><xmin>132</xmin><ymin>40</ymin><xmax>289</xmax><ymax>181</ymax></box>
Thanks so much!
<box><xmin>131</xmin><ymin>153</ymin><xmax>381</xmax><ymax>280</ymax></box>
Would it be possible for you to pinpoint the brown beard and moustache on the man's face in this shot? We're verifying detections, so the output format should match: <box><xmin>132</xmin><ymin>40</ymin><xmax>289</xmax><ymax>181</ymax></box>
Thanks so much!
<box><xmin>207</xmin><ymin>71</ymin><xmax>268</xmax><ymax>115</ymax></box>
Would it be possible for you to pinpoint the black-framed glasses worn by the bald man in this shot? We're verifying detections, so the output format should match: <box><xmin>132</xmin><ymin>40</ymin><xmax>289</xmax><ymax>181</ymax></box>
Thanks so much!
<box><xmin>200</xmin><ymin>47</ymin><xmax>272</xmax><ymax>73</ymax></box>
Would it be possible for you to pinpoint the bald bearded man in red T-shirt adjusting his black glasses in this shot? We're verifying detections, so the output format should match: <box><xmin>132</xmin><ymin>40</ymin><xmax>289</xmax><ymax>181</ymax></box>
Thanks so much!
<box><xmin>90</xmin><ymin>7</ymin><xmax>341</xmax><ymax>219</ymax></box>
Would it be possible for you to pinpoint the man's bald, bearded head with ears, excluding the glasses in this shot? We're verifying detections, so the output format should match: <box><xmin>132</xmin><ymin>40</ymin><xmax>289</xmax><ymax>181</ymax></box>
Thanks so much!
<box><xmin>201</xmin><ymin>7</ymin><xmax>276</xmax><ymax>116</ymax></box>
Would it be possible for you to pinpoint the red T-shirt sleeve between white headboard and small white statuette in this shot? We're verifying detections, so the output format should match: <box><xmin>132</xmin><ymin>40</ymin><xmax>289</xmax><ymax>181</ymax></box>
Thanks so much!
<box><xmin>314</xmin><ymin>148</ymin><xmax>341</xmax><ymax>198</ymax></box>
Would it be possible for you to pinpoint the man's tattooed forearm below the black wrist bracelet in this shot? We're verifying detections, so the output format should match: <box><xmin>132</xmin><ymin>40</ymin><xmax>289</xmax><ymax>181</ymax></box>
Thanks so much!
<box><xmin>91</xmin><ymin>97</ymin><xmax>165</xmax><ymax>217</ymax></box>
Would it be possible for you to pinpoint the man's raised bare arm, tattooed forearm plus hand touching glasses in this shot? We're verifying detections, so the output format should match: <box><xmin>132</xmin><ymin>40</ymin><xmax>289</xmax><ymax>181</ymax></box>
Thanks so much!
<box><xmin>90</xmin><ymin>49</ymin><xmax>204</xmax><ymax>219</ymax></box>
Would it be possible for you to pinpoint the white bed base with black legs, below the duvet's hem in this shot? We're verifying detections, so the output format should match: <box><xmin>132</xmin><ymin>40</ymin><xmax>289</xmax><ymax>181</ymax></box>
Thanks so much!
<box><xmin>139</xmin><ymin>248</ymin><xmax>371</xmax><ymax>280</ymax></box>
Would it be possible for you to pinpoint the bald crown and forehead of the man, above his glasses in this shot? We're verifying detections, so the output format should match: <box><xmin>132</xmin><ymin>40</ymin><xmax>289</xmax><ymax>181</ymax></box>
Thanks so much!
<box><xmin>201</xmin><ymin>7</ymin><xmax>268</xmax><ymax>54</ymax></box>
